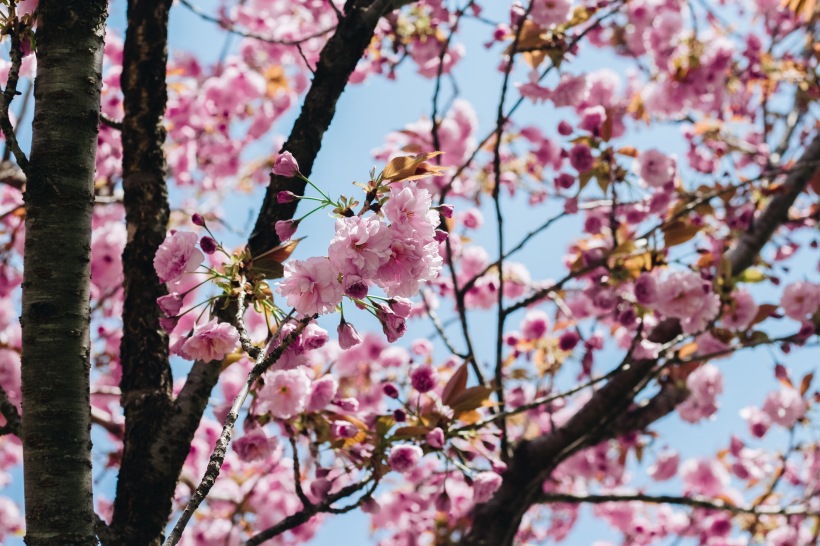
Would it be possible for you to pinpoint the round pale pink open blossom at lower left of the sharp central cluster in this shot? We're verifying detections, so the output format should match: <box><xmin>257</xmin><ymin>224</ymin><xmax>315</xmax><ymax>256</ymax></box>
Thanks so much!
<box><xmin>277</xmin><ymin>256</ymin><xmax>342</xmax><ymax>315</ymax></box>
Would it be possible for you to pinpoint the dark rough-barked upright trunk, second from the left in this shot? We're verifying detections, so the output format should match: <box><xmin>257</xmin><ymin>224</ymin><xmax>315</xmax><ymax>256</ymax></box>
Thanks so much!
<box><xmin>109</xmin><ymin>0</ymin><xmax>179</xmax><ymax>546</ymax></box>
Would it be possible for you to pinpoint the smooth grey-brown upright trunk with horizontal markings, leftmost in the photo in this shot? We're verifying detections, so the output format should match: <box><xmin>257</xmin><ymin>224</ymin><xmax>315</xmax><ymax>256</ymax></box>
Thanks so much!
<box><xmin>20</xmin><ymin>0</ymin><xmax>108</xmax><ymax>546</ymax></box>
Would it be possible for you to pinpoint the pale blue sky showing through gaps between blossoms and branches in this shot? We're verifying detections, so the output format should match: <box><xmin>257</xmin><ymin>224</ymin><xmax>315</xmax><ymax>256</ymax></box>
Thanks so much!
<box><xmin>4</xmin><ymin>0</ymin><xmax>818</xmax><ymax>546</ymax></box>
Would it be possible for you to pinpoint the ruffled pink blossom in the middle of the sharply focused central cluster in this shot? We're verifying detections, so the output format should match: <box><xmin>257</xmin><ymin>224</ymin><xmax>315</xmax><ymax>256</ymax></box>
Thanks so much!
<box><xmin>327</xmin><ymin>214</ymin><xmax>393</xmax><ymax>279</ymax></box>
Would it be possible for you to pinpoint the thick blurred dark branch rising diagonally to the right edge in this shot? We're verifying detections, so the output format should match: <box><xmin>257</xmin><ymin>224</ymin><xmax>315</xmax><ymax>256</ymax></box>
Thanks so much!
<box><xmin>462</xmin><ymin>135</ymin><xmax>820</xmax><ymax>546</ymax></box>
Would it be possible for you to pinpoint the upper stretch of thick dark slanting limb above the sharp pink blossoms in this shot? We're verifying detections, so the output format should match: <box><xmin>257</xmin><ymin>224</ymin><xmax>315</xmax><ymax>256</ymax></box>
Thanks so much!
<box><xmin>248</xmin><ymin>0</ymin><xmax>410</xmax><ymax>255</ymax></box>
